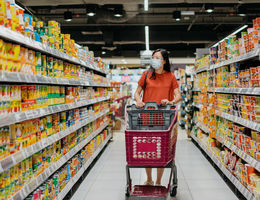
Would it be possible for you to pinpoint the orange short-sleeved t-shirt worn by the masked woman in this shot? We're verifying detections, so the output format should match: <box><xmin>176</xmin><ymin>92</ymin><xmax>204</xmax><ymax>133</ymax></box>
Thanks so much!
<box><xmin>138</xmin><ymin>71</ymin><xmax>179</xmax><ymax>104</ymax></box>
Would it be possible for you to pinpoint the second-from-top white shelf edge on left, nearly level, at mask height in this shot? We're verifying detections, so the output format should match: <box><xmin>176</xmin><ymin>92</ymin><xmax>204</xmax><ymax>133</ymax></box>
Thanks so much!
<box><xmin>0</xmin><ymin>71</ymin><xmax>110</xmax><ymax>87</ymax></box>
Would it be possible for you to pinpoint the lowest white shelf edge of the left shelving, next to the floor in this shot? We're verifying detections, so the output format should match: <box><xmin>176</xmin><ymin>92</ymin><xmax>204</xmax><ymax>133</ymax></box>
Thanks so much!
<box><xmin>55</xmin><ymin>134</ymin><xmax>112</xmax><ymax>200</ymax></box>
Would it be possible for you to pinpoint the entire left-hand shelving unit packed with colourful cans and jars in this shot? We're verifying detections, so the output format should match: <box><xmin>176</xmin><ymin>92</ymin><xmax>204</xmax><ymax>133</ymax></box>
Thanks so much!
<box><xmin>0</xmin><ymin>0</ymin><xmax>111</xmax><ymax>200</ymax></box>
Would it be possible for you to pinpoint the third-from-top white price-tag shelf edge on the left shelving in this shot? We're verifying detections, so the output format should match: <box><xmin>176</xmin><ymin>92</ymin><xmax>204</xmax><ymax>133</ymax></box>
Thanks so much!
<box><xmin>0</xmin><ymin>96</ymin><xmax>110</xmax><ymax>127</ymax></box>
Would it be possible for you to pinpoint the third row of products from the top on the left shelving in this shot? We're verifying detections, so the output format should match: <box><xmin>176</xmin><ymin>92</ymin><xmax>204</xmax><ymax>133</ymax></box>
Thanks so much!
<box><xmin>0</xmin><ymin>85</ymin><xmax>108</xmax><ymax>115</ymax></box>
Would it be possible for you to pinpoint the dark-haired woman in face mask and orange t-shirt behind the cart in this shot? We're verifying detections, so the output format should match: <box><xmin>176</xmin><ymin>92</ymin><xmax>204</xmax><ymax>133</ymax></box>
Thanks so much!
<box><xmin>135</xmin><ymin>49</ymin><xmax>181</xmax><ymax>185</ymax></box>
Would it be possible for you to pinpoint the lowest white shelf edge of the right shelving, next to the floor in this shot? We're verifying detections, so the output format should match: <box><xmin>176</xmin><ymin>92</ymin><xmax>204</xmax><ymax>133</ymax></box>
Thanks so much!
<box><xmin>191</xmin><ymin>134</ymin><xmax>255</xmax><ymax>200</ymax></box>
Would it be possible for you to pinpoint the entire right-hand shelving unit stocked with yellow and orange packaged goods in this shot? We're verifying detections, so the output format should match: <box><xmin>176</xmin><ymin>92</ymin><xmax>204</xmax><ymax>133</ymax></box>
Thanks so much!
<box><xmin>191</xmin><ymin>18</ymin><xmax>260</xmax><ymax>199</ymax></box>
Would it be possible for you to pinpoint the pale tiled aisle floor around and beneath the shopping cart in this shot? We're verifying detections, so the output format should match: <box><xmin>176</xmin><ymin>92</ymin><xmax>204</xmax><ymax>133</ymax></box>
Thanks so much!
<box><xmin>72</xmin><ymin>130</ymin><xmax>238</xmax><ymax>200</ymax></box>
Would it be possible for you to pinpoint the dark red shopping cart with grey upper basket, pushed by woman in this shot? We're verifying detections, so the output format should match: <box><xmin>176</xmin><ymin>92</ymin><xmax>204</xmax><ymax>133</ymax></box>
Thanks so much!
<box><xmin>125</xmin><ymin>102</ymin><xmax>177</xmax><ymax>200</ymax></box>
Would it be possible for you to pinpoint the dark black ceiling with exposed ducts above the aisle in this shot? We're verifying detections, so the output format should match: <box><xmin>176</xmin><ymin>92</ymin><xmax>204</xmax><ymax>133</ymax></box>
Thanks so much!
<box><xmin>16</xmin><ymin>0</ymin><xmax>260</xmax><ymax>57</ymax></box>
